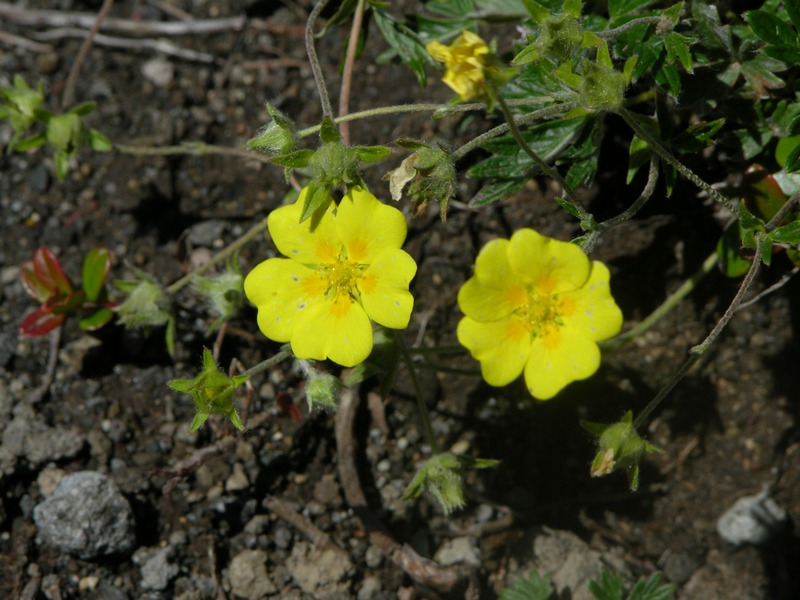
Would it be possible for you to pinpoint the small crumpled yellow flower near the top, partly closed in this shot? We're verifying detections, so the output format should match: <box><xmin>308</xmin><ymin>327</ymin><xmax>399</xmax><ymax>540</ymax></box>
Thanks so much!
<box><xmin>425</xmin><ymin>31</ymin><xmax>489</xmax><ymax>102</ymax></box>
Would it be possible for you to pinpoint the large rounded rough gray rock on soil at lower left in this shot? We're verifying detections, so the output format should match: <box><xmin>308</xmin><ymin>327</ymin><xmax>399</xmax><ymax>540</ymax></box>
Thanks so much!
<box><xmin>33</xmin><ymin>471</ymin><xmax>136</xmax><ymax>560</ymax></box>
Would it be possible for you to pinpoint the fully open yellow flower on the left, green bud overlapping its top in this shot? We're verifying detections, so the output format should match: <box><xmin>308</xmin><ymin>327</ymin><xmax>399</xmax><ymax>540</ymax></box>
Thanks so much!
<box><xmin>244</xmin><ymin>187</ymin><xmax>417</xmax><ymax>367</ymax></box>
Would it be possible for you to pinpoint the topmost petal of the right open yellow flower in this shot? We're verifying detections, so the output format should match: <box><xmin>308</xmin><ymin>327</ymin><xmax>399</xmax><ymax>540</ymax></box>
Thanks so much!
<box><xmin>508</xmin><ymin>229</ymin><xmax>591</xmax><ymax>294</ymax></box>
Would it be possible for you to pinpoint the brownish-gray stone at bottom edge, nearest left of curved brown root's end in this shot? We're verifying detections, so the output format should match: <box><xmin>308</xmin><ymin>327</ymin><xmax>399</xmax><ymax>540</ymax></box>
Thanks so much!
<box><xmin>286</xmin><ymin>542</ymin><xmax>355</xmax><ymax>600</ymax></box>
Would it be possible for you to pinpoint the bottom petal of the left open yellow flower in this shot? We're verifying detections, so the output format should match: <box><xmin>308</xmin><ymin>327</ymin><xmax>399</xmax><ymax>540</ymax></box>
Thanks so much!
<box><xmin>291</xmin><ymin>295</ymin><xmax>372</xmax><ymax>367</ymax></box>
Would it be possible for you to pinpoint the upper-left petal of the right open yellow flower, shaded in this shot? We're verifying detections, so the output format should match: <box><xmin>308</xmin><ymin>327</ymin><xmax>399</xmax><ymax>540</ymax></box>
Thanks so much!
<box><xmin>458</xmin><ymin>239</ymin><xmax>527</xmax><ymax>322</ymax></box>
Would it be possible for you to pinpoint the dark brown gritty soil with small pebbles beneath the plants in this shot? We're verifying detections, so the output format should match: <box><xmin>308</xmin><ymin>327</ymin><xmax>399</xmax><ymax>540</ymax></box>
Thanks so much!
<box><xmin>0</xmin><ymin>0</ymin><xmax>800</xmax><ymax>599</ymax></box>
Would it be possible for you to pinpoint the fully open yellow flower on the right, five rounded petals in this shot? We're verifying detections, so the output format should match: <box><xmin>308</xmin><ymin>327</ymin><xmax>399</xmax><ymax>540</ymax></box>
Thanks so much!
<box><xmin>458</xmin><ymin>229</ymin><xmax>622</xmax><ymax>400</ymax></box>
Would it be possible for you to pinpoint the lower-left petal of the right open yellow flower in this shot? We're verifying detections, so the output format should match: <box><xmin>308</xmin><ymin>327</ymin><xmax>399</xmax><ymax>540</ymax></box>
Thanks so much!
<box><xmin>456</xmin><ymin>317</ymin><xmax>531</xmax><ymax>386</ymax></box>
